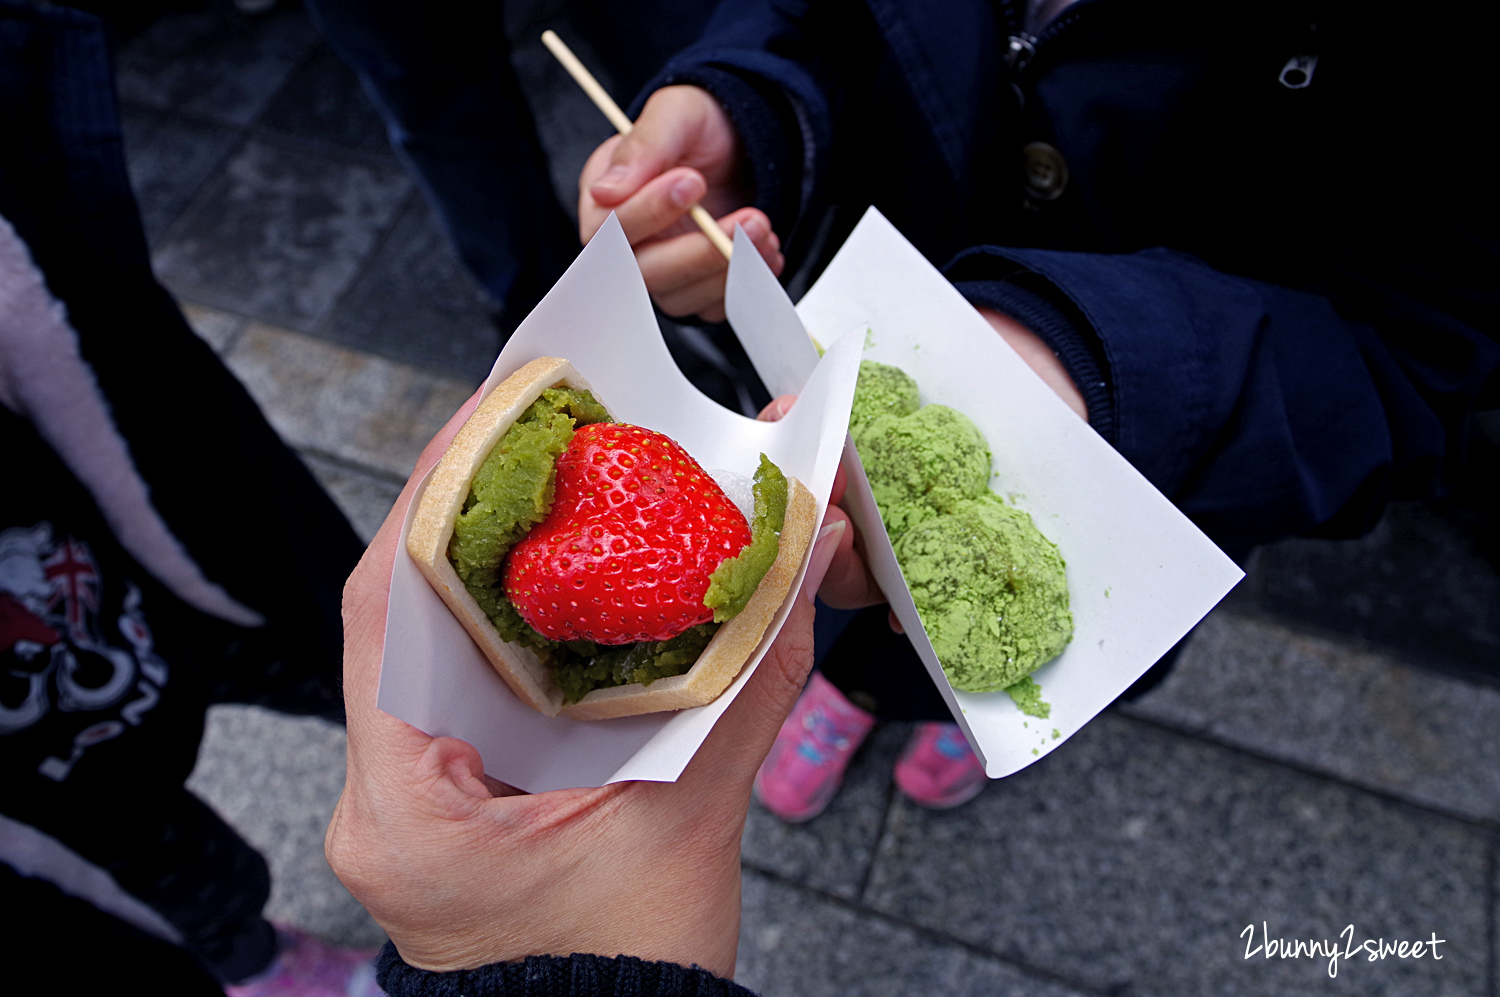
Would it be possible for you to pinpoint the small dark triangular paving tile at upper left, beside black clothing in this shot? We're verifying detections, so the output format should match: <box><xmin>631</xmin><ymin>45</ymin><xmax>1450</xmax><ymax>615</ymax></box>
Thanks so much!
<box><xmin>120</xmin><ymin>105</ymin><xmax>240</xmax><ymax>246</ymax></box>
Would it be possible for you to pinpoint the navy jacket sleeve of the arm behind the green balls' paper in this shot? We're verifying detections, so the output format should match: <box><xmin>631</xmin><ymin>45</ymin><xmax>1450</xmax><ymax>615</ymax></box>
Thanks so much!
<box><xmin>948</xmin><ymin>247</ymin><xmax>1500</xmax><ymax>550</ymax></box>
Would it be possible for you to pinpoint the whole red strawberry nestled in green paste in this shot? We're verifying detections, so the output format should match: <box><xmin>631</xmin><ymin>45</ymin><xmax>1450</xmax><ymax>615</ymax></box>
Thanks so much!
<box><xmin>504</xmin><ymin>423</ymin><xmax>750</xmax><ymax>645</ymax></box>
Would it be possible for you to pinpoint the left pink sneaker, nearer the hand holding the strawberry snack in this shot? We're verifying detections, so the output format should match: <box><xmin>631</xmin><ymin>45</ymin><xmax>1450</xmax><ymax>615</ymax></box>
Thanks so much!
<box><xmin>755</xmin><ymin>672</ymin><xmax>875</xmax><ymax>823</ymax></box>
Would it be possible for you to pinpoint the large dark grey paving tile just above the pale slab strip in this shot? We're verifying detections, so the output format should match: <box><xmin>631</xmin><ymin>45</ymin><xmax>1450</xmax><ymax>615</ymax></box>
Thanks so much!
<box><xmin>155</xmin><ymin>139</ymin><xmax>411</xmax><ymax>330</ymax></box>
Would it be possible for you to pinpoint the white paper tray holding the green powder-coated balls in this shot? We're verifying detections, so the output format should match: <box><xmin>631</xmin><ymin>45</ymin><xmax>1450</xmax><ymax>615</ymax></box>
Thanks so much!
<box><xmin>726</xmin><ymin>208</ymin><xmax>1244</xmax><ymax>778</ymax></box>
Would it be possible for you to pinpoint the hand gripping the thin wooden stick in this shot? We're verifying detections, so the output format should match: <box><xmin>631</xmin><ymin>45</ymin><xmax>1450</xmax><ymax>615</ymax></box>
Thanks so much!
<box><xmin>578</xmin><ymin>87</ymin><xmax>786</xmax><ymax>322</ymax></box>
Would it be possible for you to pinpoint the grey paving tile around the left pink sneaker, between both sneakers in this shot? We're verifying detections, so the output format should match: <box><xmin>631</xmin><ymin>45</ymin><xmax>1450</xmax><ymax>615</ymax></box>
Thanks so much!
<box><xmin>741</xmin><ymin>724</ymin><xmax>911</xmax><ymax>900</ymax></box>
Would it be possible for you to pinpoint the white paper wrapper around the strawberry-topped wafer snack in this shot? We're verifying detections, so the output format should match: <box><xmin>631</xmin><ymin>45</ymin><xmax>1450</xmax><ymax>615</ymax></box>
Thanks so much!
<box><xmin>377</xmin><ymin>216</ymin><xmax>860</xmax><ymax>792</ymax></box>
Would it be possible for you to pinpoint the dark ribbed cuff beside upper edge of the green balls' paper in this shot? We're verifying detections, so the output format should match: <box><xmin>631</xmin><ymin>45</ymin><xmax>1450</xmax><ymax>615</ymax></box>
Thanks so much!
<box><xmin>947</xmin><ymin>255</ymin><xmax>1118</xmax><ymax>445</ymax></box>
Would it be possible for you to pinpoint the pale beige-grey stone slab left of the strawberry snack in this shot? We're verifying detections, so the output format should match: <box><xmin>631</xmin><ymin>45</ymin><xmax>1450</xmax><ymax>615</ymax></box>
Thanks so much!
<box><xmin>225</xmin><ymin>322</ymin><xmax>474</xmax><ymax>480</ymax></box>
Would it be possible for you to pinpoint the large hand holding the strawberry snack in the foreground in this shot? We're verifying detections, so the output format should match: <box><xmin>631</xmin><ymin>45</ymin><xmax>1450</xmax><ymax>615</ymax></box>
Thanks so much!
<box><xmin>326</xmin><ymin>396</ymin><xmax>839</xmax><ymax>976</ymax></box>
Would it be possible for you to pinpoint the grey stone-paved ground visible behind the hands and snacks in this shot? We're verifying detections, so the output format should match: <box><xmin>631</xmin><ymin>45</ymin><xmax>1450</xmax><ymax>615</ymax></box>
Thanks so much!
<box><xmin>119</xmin><ymin>4</ymin><xmax>1500</xmax><ymax>997</ymax></box>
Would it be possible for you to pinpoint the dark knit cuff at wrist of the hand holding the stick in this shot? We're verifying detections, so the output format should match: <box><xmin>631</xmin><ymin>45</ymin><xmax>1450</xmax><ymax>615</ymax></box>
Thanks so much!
<box><xmin>642</xmin><ymin>64</ymin><xmax>803</xmax><ymax>239</ymax></box>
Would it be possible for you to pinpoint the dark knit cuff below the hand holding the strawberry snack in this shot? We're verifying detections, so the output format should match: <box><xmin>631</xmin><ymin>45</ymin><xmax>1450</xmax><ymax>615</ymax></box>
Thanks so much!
<box><xmin>375</xmin><ymin>942</ymin><xmax>755</xmax><ymax>997</ymax></box>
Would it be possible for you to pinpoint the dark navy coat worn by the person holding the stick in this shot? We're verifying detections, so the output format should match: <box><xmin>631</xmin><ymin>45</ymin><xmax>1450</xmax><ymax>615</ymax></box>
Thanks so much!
<box><xmin>642</xmin><ymin>0</ymin><xmax>1500</xmax><ymax>553</ymax></box>
